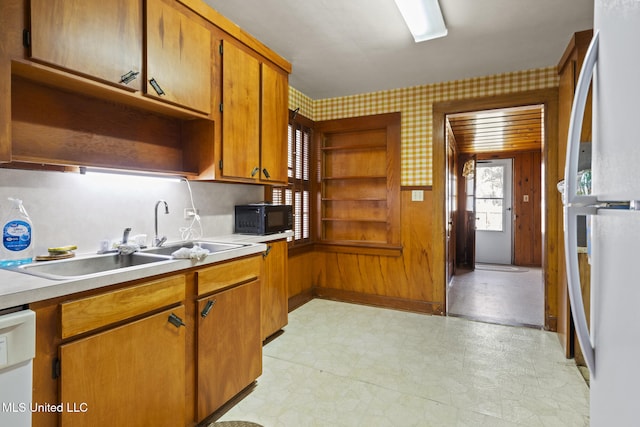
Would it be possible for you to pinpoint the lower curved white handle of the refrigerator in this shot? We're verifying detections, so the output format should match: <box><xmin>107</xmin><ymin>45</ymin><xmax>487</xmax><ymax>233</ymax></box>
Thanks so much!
<box><xmin>564</xmin><ymin>206</ymin><xmax>597</xmax><ymax>377</ymax></box>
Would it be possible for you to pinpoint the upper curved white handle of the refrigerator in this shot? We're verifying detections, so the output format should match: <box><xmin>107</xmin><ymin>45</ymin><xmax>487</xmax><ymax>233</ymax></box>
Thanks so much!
<box><xmin>564</xmin><ymin>31</ymin><xmax>599</xmax><ymax>206</ymax></box>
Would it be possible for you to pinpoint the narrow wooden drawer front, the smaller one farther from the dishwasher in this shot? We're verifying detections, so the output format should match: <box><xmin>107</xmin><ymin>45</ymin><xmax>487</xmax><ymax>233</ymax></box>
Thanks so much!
<box><xmin>197</xmin><ymin>257</ymin><xmax>261</xmax><ymax>295</ymax></box>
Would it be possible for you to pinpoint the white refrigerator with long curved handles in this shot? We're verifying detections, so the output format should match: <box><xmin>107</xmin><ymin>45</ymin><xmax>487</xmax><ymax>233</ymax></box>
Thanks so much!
<box><xmin>564</xmin><ymin>0</ymin><xmax>640</xmax><ymax>426</ymax></box>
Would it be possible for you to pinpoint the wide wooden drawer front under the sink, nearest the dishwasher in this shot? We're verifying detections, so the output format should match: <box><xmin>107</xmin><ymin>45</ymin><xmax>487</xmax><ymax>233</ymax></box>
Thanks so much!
<box><xmin>60</xmin><ymin>275</ymin><xmax>185</xmax><ymax>339</ymax></box>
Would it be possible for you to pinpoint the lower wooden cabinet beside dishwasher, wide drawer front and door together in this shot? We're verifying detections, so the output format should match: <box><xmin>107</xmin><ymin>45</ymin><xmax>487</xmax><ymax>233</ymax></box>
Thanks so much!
<box><xmin>56</xmin><ymin>275</ymin><xmax>186</xmax><ymax>427</ymax></box>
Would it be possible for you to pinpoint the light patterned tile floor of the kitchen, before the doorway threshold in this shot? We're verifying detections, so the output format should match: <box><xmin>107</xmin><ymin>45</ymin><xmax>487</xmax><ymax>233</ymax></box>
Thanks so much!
<box><xmin>219</xmin><ymin>299</ymin><xmax>589</xmax><ymax>427</ymax></box>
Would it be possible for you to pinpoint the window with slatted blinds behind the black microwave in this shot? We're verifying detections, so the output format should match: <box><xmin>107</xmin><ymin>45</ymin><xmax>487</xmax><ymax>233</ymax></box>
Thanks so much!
<box><xmin>271</xmin><ymin>115</ymin><xmax>313</xmax><ymax>246</ymax></box>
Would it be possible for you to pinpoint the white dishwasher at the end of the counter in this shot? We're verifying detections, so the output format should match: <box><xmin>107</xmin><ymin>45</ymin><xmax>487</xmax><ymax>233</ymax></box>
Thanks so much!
<box><xmin>0</xmin><ymin>310</ymin><xmax>36</xmax><ymax>427</ymax></box>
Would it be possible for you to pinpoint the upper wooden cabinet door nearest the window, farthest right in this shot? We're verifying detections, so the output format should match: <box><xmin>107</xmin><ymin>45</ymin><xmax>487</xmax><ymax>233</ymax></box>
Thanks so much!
<box><xmin>260</xmin><ymin>64</ymin><xmax>289</xmax><ymax>184</ymax></box>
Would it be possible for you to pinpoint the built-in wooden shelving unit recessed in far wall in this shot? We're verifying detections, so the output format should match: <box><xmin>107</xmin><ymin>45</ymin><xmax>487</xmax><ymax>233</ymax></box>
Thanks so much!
<box><xmin>319</xmin><ymin>115</ymin><xmax>400</xmax><ymax>254</ymax></box>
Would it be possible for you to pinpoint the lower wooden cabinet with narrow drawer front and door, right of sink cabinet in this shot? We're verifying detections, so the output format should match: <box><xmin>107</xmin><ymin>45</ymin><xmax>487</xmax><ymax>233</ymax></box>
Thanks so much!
<box><xmin>196</xmin><ymin>257</ymin><xmax>262</xmax><ymax>421</ymax></box>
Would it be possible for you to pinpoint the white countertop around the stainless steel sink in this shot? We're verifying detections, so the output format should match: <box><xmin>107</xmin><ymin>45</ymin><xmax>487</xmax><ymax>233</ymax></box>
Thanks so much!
<box><xmin>0</xmin><ymin>231</ymin><xmax>293</xmax><ymax>310</ymax></box>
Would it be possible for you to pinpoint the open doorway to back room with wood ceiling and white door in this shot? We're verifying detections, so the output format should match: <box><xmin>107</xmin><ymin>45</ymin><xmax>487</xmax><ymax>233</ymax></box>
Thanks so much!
<box><xmin>445</xmin><ymin>104</ymin><xmax>545</xmax><ymax>328</ymax></box>
